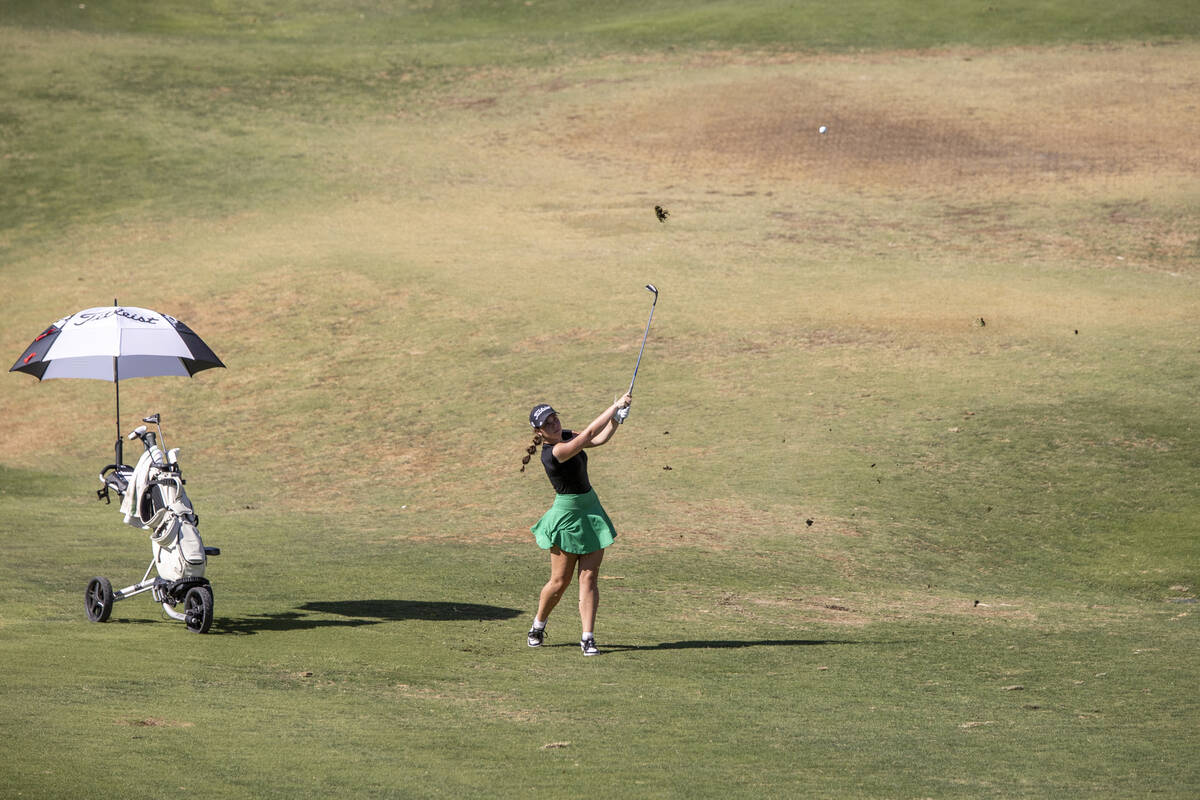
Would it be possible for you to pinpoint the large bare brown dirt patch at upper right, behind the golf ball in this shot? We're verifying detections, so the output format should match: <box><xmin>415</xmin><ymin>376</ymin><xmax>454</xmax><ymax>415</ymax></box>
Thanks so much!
<box><xmin>556</xmin><ymin>46</ymin><xmax>1200</xmax><ymax>187</ymax></box>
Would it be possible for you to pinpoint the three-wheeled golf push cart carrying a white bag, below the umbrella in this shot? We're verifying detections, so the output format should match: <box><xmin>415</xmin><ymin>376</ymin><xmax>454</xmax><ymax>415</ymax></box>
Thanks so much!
<box><xmin>84</xmin><ymin>414</ymin><xmax>221</xmax><ymax>633</ymax></box>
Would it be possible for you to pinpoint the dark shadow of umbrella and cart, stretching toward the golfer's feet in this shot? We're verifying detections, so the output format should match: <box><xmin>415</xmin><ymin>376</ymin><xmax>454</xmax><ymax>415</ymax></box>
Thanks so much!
<box><xmin>212</xmin><ymin>600</ymin><xmax>522</xmax><ymax>634</ymax></box>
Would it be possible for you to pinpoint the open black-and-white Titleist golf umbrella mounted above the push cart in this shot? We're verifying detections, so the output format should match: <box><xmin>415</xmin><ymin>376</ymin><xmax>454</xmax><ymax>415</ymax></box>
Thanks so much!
<box><xmin>8</xmin><ymin>302</ymin><xmax>224</xmax><ymax>461</ymax></box>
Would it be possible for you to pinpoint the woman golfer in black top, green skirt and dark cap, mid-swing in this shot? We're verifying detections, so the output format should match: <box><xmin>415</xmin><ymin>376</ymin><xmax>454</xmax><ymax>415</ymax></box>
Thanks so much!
<box><xmin>521</xmin><ymin>395</ymin><xmax>632</xmax><ymax>656</ymax></box>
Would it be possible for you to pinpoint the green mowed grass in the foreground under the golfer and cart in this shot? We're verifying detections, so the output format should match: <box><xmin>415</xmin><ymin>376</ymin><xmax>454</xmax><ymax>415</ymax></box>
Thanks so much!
<box><xmin>4</xmin><ymin>489</ymin><xmax>1195</xmax><ymax>796</ymax></box>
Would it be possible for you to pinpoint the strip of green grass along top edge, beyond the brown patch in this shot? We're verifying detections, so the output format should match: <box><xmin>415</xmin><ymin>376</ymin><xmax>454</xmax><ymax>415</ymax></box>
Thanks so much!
<box><xmin>5</xmin><ymin>0</ymin><xmax>1196</xmax><ymax>47</ymax></box>
